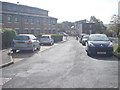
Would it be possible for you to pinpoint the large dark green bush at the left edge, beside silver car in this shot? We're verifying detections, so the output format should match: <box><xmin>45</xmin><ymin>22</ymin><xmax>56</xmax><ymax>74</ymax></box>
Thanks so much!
<box><xmin>2</xmin><ymin>28</ymin><xmax>16</xmax><ymax>49</ymax></box>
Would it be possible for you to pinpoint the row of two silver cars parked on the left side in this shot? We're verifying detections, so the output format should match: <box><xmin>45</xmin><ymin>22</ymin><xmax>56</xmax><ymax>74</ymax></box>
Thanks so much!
<box><xmin>12</xmin><ymin>34</ymin><xmax>54</xmax><ymax>52</ymax></box>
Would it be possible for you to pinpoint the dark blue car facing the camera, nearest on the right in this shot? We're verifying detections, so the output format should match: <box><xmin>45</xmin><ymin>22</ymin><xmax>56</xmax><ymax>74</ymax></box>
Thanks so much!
<box><xmin>86</xmin><ymin>34</ymin><xmax>113</xmax><ymax>56</ymax></box>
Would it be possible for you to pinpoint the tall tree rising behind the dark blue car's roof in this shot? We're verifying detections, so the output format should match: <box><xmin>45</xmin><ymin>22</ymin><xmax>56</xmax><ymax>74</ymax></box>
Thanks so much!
<box><xmin>90</xmin><ymin>16</ymin><xmax>106</xmax><ymax>33</ymax></box>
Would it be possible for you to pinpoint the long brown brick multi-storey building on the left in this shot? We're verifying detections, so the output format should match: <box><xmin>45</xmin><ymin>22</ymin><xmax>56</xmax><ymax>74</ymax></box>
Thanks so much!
<box><xmin>0</xmin><ymin>2</ymin><xmax>57</xmax><ymax>35</ymax></box>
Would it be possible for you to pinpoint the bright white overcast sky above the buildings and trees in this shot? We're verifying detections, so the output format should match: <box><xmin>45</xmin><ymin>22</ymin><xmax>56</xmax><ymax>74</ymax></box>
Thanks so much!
<box><xmin>2</xmin><ymin>0</ymin><xmax>120</xmax><ymax>24</ymax></box>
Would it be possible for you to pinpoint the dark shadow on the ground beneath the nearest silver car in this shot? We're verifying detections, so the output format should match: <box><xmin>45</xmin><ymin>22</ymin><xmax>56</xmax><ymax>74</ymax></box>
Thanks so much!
<box><xmin>12</xmin><ymin>50</ymin><xmax>39</xmax><ymax>58</ymax></box>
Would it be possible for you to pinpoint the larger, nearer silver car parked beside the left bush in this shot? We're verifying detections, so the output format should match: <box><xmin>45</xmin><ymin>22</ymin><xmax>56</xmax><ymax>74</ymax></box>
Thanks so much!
<box><xmin>12</xmin><ymin>34</ymin><xmax>40</xmax><ymax>52</ymax></box>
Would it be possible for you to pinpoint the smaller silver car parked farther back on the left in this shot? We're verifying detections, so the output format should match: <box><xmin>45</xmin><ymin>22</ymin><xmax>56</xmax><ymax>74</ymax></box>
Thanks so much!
<box><xmin>40</xmin><ymin>35</ymin><xmax>54</xmax><ymax>45</ymax></box>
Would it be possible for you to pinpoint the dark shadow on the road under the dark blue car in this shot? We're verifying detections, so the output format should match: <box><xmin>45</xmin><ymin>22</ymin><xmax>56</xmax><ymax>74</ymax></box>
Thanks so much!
<box><xmin>92</xmin><ymin>55</ymin><xmax>119</xmax><ymax>61</ymax></box>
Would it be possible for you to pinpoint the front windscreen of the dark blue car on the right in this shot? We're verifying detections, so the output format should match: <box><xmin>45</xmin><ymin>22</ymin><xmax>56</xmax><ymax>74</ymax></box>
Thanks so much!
<box><xmin>89</xmin><ymin>35</ymin><xmax>109</xmax><ymax>41</ymax></box>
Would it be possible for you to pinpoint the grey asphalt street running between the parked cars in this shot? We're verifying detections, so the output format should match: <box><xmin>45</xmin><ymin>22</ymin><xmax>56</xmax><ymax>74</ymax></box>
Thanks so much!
<box><xmin>2</xmin><ymin>37</ymin><xmax>118</xmax><ymax>88</ymax></box>
